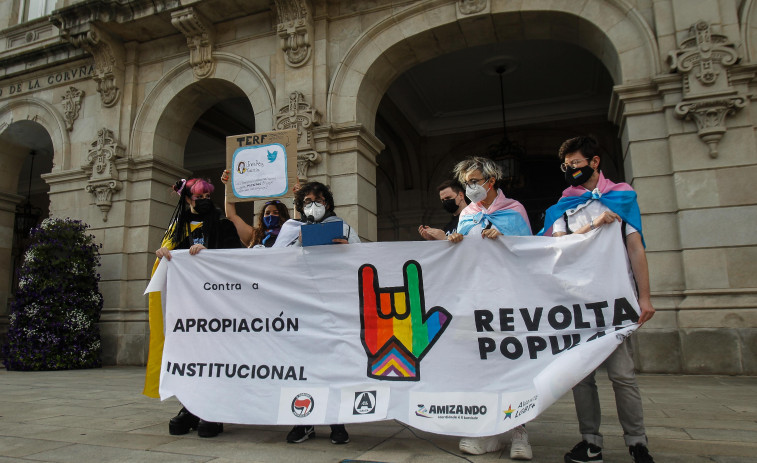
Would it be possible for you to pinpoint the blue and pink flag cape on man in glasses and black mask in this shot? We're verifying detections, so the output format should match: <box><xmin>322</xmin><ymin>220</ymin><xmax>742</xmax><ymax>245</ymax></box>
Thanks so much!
<box><xmin>537</xmin><ymin>172</ymin><xmax>646</xmax><ymax>246</ymax></box>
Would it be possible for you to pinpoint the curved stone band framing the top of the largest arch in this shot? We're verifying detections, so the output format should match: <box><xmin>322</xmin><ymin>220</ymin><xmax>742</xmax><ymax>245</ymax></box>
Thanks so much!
<box><xmin>327</xmin><ymin>0</ymin><xmax>660</xmax><ymax>132</ymax></box>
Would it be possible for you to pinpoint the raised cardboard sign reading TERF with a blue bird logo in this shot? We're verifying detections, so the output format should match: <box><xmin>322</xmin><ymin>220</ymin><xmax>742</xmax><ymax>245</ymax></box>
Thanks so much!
<box><xmin>226</xmin><ymin>129</ymin><xmax>297</xmax><ymax>203</ymax></box>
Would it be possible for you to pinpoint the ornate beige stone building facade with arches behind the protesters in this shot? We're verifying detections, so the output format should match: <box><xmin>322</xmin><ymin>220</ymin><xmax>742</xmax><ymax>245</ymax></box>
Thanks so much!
<box><xmin>0</xmin><ymin>0</ymin><xmax>757</xmax><ymax>374</ymax></box>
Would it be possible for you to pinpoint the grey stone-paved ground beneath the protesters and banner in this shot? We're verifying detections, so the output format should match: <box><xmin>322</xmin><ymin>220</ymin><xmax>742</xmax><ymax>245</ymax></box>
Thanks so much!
<box><xmin>0</xmin><ymin>367</ymin><xmax>757</xmax><ymax>463</ymax></box>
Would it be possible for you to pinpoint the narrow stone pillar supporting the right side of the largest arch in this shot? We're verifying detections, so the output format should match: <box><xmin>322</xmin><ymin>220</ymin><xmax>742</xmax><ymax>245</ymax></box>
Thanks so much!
<box><xmin>610</xmin><ymin>82</ymin><xmax>685</xmax><ymax>373</ymax></box>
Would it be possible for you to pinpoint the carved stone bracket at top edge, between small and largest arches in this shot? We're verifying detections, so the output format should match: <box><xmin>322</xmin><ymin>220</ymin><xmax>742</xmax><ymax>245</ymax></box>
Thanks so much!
<box><xmin>276</xmin><ymin>0</ymin><xmax>313</xmax><ymax>67</ymax></box>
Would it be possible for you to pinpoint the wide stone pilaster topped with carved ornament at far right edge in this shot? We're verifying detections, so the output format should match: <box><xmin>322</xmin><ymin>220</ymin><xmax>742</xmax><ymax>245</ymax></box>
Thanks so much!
<box><xmin>668</xmin><ymin>21</ymin><xmax>757</xmax><ymax>374</ymax></box>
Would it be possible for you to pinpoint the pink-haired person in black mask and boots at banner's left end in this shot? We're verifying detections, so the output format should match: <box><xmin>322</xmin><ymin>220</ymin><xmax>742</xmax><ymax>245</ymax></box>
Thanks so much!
<box><xmin>150</xmin><ymin>178</ymin><xmax>241</xmax><ymax>437</ymax></box>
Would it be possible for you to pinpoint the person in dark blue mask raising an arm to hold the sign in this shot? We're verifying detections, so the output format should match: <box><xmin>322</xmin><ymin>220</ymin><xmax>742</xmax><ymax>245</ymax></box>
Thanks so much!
<box><xmin>221</xmin><ymin>169</ymin><xmax>290</xmax><ymax>248</ymax></box>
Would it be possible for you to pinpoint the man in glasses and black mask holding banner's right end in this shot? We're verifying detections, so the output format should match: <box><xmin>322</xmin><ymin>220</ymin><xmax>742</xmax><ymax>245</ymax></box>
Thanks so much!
<box><xmin>539</xmin><ymin>136</ymin><xmax>655</xmax><ymax>463</ymax></box>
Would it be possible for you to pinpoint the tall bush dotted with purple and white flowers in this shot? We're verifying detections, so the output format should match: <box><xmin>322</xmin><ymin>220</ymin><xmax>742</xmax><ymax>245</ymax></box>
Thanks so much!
<box><xmin>3</xmin><ymin>218</ymin><xmax>103</xmax><ymax>370</ymax></box>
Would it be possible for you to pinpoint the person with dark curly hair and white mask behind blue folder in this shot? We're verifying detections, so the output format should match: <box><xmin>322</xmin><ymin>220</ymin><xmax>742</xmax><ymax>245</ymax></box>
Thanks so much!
<box><xmin>273</xmin><ymin>182</ymin><xmax>360</xmax><ymax>248</ymax></box>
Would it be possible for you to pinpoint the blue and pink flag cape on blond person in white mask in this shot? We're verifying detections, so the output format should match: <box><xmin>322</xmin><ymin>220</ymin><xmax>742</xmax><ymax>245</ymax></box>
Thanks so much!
<box><xmin>457</xmin><ymin>190</ymin><xmax>531</xmax><ymax>236</ymax></box>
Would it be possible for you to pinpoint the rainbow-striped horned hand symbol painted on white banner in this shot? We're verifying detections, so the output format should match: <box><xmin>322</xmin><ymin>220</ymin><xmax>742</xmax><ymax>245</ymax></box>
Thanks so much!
<box><xmin>358</xmin><ymin>260</ymin><xmax>452</xmax><ymax>381</ymax></box>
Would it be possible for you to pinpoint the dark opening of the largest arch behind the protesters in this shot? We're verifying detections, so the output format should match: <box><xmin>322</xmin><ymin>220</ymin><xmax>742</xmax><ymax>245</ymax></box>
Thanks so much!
<box><xmin>376</xmin><ymin>40</ymin><xmax>625</xmax><ymax>240</ymax></box>
